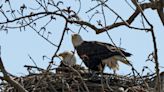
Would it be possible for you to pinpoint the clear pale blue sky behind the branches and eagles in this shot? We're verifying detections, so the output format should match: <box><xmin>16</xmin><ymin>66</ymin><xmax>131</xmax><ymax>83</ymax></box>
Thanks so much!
<box><xmin>0</xmin><ymin>0</ymin><xmax>164</xmax><ymax>75</ymax></box>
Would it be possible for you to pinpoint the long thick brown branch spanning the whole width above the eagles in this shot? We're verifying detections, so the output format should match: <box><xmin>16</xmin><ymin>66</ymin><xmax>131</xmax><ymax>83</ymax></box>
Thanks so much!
<box><xmin>0</xmin><ymin>1</ymin><xmax>164</xmax><ymax>34</ymax></box>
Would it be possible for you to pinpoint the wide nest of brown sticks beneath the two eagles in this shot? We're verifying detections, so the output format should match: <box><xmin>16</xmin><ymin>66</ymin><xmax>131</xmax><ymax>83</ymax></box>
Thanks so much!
<box><xmin>0</xmin><ymin>65</ymin><xmax>154</xmax><ymax>92</ymax></box>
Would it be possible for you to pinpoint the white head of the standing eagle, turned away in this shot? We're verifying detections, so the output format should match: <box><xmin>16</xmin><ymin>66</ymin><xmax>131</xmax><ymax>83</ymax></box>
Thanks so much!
<box><xmin>72</xmin><ymin>34</ymin><xmax>83</xmax><ymax>47</ymax></box>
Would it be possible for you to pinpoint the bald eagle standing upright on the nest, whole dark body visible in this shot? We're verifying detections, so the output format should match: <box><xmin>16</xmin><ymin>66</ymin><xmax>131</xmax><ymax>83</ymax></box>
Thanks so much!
<box><xmin>72</xmin><ymin>34</ymin><xmax>131</xmax><ymax>71</ymax></box>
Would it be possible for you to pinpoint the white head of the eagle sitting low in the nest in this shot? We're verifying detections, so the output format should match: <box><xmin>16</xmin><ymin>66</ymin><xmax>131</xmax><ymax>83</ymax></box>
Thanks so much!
<box><xmin>58</xmin><ymin>51</ymin><xmax>76</xmax><ymax>66</ymax></box>
